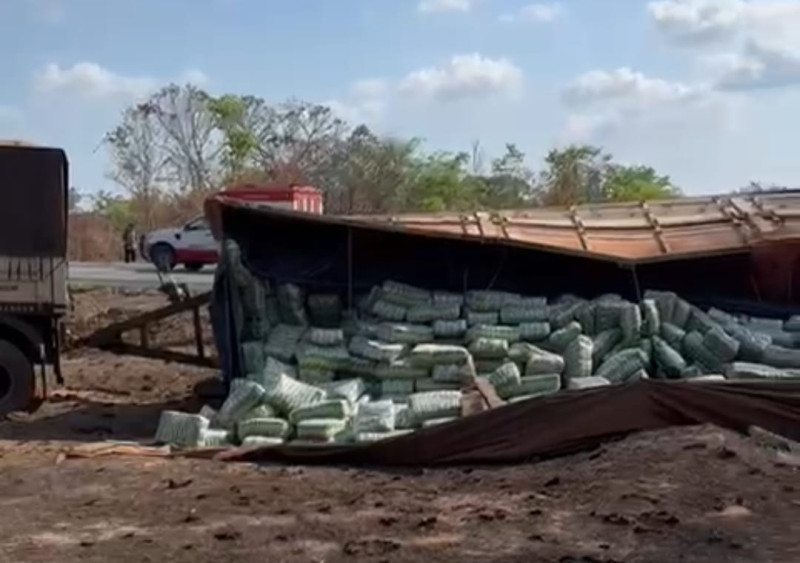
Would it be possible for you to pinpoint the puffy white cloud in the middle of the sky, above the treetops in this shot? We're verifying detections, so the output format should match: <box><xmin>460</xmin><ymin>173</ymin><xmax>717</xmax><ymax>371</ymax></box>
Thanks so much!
<box><xmin>399</xmin><ymin>53</ymin><xmax>523</xmax><ymax>100</ymax></box>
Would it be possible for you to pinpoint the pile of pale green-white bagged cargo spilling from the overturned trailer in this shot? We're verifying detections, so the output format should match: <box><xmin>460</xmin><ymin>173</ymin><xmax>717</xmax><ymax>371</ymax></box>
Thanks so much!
<box><xmin>156</xmin><ymin>242</ymin><xmax>800</xmax><ymax>446</ymax></box>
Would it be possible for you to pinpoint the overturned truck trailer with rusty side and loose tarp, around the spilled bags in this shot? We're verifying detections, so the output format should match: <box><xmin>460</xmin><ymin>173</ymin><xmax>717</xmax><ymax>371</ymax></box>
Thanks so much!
<box><xmin>194</xmin><ymin>194</ymin><xmax>800</xmax><ymax>464</ymax></box>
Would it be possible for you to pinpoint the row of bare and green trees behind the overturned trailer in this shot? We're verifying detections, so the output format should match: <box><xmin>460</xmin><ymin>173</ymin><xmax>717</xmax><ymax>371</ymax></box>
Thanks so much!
<box><xmin>86</xmin><ymin>84</ymin><xmax>680</xmax><ymax>234</ymax></box>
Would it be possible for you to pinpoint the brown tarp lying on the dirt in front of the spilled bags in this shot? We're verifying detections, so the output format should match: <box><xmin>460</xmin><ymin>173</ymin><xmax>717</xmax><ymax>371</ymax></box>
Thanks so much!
<box><xmin>219</xmin><ymin>381</ymin><xmax>800</xmax><ymax>467</ymax></box>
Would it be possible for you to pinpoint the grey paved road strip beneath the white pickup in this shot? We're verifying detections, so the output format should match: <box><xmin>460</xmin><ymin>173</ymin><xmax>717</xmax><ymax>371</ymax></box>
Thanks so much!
<box><xmin>69</xmin><ymin>262</ymin><xmax>214</xmax><ymax>291</ymax></box>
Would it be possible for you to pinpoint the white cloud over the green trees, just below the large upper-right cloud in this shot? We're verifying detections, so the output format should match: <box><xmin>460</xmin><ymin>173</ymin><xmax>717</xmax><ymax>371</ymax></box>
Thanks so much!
<box><xmin>563</xmin><ymin>67</ymin><xmax>704</xmax><ymax>106</ymax></box>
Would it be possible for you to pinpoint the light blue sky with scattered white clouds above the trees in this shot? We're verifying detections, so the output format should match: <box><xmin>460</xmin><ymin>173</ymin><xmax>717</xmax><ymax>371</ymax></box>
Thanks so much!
<box><xmin>0</xmin><ymin>0</ymin><xmax>800</xmax><ymax>194</ymax></box>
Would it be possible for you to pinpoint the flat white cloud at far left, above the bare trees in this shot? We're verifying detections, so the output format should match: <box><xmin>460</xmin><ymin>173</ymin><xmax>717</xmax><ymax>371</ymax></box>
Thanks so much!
<box><xmin>34</xmin><ymin>62</ymin><xmax>156</xmax><ymax>98</ymax></box>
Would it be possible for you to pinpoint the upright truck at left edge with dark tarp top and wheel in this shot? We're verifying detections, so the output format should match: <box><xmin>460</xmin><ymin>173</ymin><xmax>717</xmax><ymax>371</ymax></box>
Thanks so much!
<box><xmin>0</xmin><ymin>143</ymin><xmax>69</xmax><ymax>414</ymax></box>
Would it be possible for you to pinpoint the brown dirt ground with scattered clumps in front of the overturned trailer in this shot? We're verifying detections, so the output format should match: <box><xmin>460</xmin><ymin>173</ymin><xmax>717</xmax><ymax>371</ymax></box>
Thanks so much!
<box><xmin>0</xmin><ymin>292</ymin><xmax>800</xmax><ymax>563</ymax></box>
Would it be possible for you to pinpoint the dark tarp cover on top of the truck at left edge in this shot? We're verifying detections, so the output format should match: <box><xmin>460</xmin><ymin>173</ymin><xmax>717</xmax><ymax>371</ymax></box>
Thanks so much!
<box><xmin>0</xmin><ymin>146</ymin><xmax>68</xmax><ymax>257</ymax></box>
